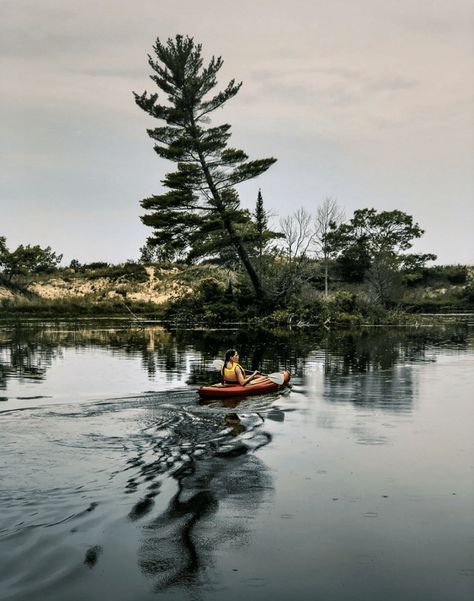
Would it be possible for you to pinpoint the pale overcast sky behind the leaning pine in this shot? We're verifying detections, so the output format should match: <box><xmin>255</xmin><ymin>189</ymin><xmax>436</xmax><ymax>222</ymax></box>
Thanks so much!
<box><xmin>0</xmin><ymin>0</ymin><xmax>474</xmax><ymax>263</ymax></box>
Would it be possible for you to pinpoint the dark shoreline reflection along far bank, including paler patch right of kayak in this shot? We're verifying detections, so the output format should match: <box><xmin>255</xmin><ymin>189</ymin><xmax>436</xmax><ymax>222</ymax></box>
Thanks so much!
<box><xmin>0</xmin><ymin>320</ymin><xmax>472</xmax><ymax>411</ymax></box>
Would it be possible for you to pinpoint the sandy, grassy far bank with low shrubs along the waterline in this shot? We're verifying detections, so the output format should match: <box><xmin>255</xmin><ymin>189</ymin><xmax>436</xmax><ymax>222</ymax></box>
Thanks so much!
<box><xmin>0</xmin><ymin>263</ymin><xmax>474</xmax><ymax>327</ymax></box>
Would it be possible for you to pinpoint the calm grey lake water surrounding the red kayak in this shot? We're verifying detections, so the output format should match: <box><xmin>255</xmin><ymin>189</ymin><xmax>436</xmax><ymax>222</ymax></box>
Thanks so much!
<box><xmin>0</xmin><ymin>318</ymin><xmax>474</xmax><ymax>601</ymax></box>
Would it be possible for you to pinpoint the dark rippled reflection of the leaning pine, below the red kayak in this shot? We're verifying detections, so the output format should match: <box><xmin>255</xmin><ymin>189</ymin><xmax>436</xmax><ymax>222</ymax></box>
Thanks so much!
<box><xmin>120</xmin><ymin>398</ymin><xmax>273</xmax><ymax>591</ymax></box>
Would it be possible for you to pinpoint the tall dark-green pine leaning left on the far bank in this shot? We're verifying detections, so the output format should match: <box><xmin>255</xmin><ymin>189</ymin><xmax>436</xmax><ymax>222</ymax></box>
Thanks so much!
<box><xmin>134</xmin><ymin>35</ymin><xmax>276</xmax><ymax>300</ymax></box>
